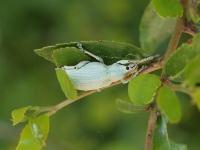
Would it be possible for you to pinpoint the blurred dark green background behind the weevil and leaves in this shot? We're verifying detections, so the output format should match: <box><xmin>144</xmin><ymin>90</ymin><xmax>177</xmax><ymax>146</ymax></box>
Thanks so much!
<box><xmin>0</xmin><ymin>0</ymin><xmax>200</xmax><ymax>150</ymax></box>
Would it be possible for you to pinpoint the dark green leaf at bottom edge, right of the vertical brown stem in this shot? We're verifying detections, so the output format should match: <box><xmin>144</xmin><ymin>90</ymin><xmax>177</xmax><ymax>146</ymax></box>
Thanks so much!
<box><xmin>153</xmin><ymin>116</ymin><xmax>187</xmax><ymax>150</ymax></box>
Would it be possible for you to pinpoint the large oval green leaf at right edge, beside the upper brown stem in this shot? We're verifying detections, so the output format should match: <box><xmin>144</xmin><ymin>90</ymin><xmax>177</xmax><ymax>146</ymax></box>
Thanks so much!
<box><xmin>164</xmin><ymin>34</ymin><xmax>200</xmax><ymax>79</ymax></box>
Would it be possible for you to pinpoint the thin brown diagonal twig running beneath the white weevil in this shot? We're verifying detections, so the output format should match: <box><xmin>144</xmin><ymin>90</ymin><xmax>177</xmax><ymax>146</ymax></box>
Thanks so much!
<box><xmin>47</xmin><ymin>62</ymin><xmax>162</xmax><ymax>116</ymax></box>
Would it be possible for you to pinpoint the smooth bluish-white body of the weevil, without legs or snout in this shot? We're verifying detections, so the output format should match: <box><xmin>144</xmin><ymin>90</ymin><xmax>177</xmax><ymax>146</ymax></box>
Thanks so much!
<box><xmin>63</xmin><ymin>60</ymin><xmax>135</xmax><ymax>91</ymax></box>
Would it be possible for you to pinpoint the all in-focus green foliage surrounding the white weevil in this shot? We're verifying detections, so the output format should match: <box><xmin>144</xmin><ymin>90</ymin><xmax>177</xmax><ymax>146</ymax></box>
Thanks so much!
<box><xmin>3</xmin><ymin>0</ymin><xmax>200</xmax><ymax>150</ymax></box>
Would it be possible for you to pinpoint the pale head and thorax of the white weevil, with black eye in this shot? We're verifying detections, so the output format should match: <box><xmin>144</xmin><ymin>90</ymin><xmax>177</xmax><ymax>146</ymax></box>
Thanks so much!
<box><xmin>108</xmin><ymin>60</ymin><xmax>137</xmax><ymax>82</ymax></box>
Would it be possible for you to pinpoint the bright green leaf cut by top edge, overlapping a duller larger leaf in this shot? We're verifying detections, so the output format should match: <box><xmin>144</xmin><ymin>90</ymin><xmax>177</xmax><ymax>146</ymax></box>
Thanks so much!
<box><xmin>152</xmin><ymin>0</ymin><xmax>183</xmax><ymax>17</ymax></box>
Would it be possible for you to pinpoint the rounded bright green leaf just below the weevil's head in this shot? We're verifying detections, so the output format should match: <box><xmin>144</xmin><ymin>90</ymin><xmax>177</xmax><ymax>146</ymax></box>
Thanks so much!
<box><xmin>128</xmin><ymin>74</ymin><xmax>161</xmax><ymax>105</ymax></box>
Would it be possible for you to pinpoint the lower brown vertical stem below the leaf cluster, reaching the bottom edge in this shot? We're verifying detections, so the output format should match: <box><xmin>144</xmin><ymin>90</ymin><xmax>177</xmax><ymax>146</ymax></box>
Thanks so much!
<box><xmin>144</xmin><ymin>109</ymin><xmax>157</xmax><ymax>150</ymax></box>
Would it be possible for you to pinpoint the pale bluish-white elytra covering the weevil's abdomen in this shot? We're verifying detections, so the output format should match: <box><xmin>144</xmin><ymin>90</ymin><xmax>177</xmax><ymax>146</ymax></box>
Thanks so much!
<box><xmin>63</xmin><ymin>62</ymin><xmax>112</xmax><ymax>91</ymax></box>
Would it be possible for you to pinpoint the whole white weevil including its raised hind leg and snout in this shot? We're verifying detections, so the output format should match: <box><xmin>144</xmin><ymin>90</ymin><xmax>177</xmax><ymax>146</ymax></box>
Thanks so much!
<box><xmin>62</xmin><ymin>43</ymin><xmax>158</xmax><ymax>91</ymax></box>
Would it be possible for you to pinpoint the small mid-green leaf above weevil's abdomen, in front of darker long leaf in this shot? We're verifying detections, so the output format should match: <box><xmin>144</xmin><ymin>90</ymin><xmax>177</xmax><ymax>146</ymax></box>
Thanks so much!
<box><xmin>52</xmin><ymin>47</ymin><xmax>91</xmax><ymax>67</ymax></box>
